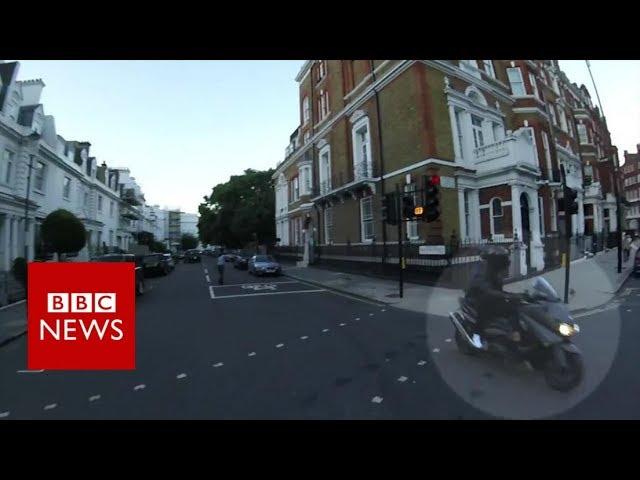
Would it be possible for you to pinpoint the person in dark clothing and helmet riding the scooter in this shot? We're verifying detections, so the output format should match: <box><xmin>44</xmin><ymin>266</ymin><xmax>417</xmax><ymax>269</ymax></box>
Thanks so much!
<box><xmin>465</xmin><ymin>245</ymin><xmax>523</xmax><ymax>347</ymax></box>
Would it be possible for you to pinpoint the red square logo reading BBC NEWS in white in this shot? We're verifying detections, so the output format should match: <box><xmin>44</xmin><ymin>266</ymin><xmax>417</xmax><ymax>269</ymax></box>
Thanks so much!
<box><xmin>27</xmin><ymin>262</ymin><xmax>136</xmax><ymax>370</ymax></box>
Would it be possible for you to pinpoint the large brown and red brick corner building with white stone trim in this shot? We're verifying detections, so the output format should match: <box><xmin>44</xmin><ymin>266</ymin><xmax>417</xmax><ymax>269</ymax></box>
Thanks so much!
<box><xmin>273</xmin><ymin>60</ymin><xmax>616</xmax><ymax>270</ymax></box>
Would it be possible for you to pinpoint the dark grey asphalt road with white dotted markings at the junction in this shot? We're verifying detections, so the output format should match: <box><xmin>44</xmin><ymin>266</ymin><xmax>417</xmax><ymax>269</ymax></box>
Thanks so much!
<box><xmin>0</xmin><ymin>257</ymin><xmax>640</xmax><ymax>419</ymax></box>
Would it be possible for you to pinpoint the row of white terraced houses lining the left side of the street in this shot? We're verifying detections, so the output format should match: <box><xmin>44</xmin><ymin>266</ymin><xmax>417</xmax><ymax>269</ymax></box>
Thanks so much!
<box><xmin>0</xmin><ymin>62</ymin><xmax>162</xmax><ymax>271</ymax></box>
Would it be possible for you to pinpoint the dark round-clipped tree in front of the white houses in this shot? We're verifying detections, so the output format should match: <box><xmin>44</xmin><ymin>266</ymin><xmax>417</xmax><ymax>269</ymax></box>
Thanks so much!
<box><xmin>41</xmin><ymin>209</ymin><xmax>87</xmax><ymax>258</ymax></box>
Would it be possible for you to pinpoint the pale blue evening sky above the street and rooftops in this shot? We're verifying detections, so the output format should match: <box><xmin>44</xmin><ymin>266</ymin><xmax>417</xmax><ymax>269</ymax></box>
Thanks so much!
<box><xmin>11</xmin><ymin>60</ymin><xmax>640</xmax><ymax>212</ymax></box>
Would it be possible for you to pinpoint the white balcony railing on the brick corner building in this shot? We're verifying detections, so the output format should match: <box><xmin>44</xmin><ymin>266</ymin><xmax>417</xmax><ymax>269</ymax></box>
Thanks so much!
<box><xmin>473</xmin><ymin>129</ymin><xmax>539</xmax><ymax>170</ymax></box>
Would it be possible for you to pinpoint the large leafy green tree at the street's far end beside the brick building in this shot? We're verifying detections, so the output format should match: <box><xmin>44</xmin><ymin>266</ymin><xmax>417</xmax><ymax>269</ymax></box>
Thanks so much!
<box><xmin>198</xmin><ymin>169</ymin><xmax>275</xmax><ymax>248</ymax></box>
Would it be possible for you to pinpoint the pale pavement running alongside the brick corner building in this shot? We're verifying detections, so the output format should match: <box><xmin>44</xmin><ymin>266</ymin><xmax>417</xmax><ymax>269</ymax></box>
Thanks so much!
<box><xmin>284</xmin><ymin>244</ymin><xmax>638</xmax><ymax>316</ymax></box>
